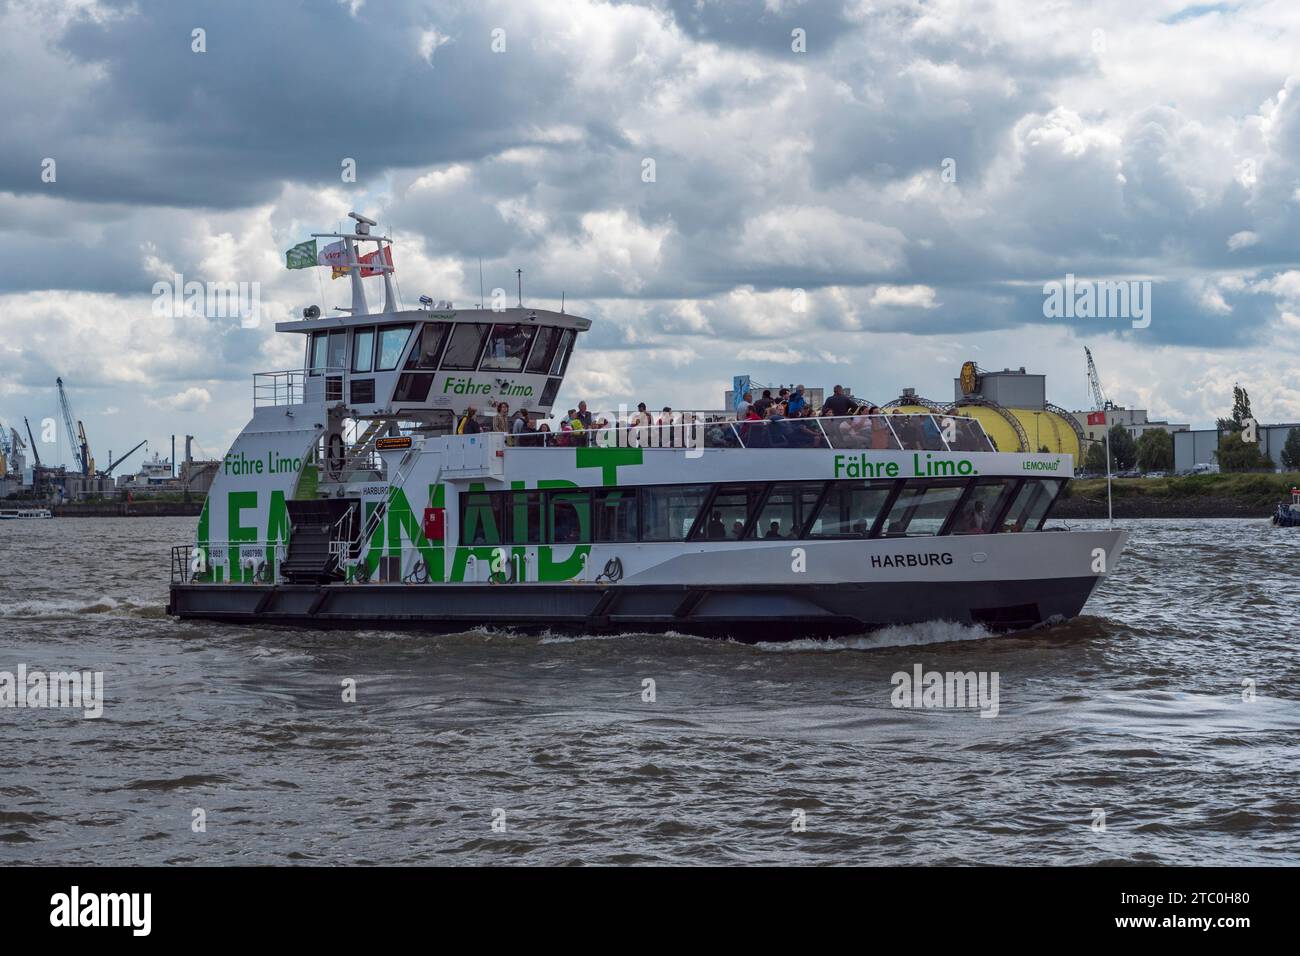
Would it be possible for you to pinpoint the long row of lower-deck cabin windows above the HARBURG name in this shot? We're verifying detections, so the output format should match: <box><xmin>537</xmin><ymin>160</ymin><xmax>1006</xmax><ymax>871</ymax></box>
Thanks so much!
<box><xmin>460</xmin><ymin>477</ymin><xmax>1062</xmax><ymax>546</ymax></box>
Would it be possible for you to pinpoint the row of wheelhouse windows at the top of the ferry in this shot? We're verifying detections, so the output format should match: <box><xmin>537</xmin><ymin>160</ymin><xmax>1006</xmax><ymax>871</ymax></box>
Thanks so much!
<box><xmin>311</xmin><ymin>323</ymin><xmax>577</xmax><ymax>375</ymax></box>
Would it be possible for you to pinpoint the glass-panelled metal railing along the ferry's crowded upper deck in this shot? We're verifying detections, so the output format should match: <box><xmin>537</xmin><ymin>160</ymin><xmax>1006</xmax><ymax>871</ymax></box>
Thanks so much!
<box><xmin>506</xmin><ymin>414</ymin><xmax>997</xmax><ymax>451</ymax></box>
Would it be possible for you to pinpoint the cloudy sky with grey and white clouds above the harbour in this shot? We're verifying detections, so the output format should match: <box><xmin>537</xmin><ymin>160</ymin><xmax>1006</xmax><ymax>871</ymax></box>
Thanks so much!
<box><xmin>0</xmin><ymin>0</ymin><xmax>1300</xmax><ymax>466</ymax></box>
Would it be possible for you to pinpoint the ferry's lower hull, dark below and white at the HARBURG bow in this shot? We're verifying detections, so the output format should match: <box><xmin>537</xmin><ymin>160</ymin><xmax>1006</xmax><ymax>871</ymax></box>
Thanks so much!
<box><xmin>169</xmin><ymin>531</ymin><xmax>1126</xmax><ymax>641</ymax></box>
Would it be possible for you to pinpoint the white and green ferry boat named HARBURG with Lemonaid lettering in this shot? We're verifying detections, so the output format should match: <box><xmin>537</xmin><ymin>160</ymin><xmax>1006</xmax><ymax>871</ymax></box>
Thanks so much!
<box><xmin>168</xmin><ymin>213</ymin><xmax>1125</xmax><ymax>641</ymax></box>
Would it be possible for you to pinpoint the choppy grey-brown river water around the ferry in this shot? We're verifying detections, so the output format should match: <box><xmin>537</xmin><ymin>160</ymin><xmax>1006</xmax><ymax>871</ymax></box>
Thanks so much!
<box><xmin>0</xmin><ymin>518</ymin><xmax>1300</xmax><ymax>865</ymax></box>
